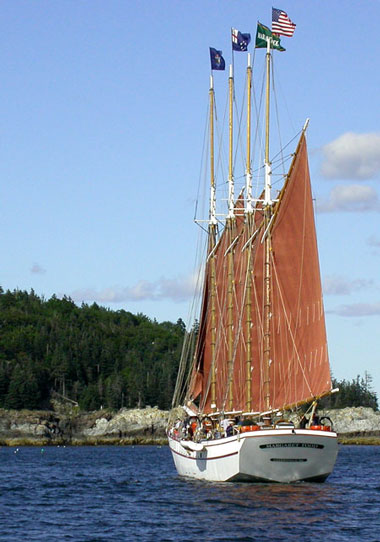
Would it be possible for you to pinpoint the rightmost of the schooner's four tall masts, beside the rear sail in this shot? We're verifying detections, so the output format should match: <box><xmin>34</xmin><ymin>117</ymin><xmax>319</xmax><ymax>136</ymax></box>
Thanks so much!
<box><xmin>263</xmin><ymin>37</ymin><xmax>273</xmax><ymax>410</ymax></box>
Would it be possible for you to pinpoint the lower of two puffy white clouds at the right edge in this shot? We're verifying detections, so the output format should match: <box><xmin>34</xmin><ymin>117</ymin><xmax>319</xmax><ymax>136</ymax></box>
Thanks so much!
<box><xmin>316</xmin><ymin>184</ymin><xmax>380</xmax><ymax>213</ymax></box>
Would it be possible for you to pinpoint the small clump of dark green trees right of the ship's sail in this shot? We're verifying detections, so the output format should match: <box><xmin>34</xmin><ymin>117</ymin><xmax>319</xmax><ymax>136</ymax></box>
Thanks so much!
<box><xmin>320</xmin><ymin>372</ymin><xmax>379</xmax><ymax>410</ymax></box>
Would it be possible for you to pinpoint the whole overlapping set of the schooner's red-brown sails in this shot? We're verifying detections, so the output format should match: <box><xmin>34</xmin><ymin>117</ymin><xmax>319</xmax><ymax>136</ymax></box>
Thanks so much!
<box><xmin>187</xmin><ymin>133</ymin><xmax>331</xmax><ymax>413</ymax></box>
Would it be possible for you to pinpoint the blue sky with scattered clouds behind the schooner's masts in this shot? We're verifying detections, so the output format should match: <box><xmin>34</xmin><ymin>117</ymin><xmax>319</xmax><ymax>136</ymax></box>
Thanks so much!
<box><xmin>0</xmin><ymin>0</ymin><xmax>380</xmax><ymax>397</ymax></box>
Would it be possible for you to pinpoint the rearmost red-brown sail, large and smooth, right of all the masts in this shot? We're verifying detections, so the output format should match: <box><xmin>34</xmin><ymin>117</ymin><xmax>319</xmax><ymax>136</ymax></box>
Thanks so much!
<box><xmin>249</xmin><ymin>134</ymin><xmax>331</xmax><ymax>410</ymax></box>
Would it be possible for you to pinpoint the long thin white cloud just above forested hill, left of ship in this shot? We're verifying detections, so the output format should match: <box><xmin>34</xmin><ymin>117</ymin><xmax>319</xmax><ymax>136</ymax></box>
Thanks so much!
<box><xmin>70</xmin><ymin>277</ymin><xmax>199</xmax><ymax>303</ymax></box>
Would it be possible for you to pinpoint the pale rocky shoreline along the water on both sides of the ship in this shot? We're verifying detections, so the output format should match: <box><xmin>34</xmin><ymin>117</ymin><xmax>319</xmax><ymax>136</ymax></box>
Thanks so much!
<box><xmin>0</xmin><ymin>407</ymin><xmax>380</xmax><ymax>446</ymax></box>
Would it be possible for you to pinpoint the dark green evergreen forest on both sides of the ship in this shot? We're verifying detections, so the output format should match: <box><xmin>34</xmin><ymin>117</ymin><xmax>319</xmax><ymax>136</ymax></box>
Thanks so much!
<box><xmin>0</xmin><ymin>287</ymin><xmax>378</xmax><ymax>410</ymax></box>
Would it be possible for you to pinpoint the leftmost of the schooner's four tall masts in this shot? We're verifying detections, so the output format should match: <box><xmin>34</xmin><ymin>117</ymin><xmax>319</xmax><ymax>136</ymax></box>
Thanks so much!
<box><xmin>208</xmin><ymin>75</ymin><xmax>217</xmax><ymax>409</ymax></box>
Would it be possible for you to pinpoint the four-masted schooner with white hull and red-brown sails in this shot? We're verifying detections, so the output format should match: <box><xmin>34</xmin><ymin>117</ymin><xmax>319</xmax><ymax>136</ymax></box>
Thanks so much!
<box><xmin>168</xmin><ymin>19</ymin><xmax>337</xmax><ymax>483</ymax></box>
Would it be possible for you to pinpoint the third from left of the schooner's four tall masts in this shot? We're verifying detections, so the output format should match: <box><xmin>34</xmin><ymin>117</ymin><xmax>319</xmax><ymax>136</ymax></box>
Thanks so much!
<box><xmin>245</xmin><ymin>53</ymin><xmax>253</xmax><ymax>412</ymax></box>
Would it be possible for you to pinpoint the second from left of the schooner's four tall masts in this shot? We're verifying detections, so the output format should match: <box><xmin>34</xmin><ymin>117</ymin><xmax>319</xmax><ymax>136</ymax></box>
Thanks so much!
<box><xmin>226</xmin><ymin>65</ymin><xmax>235</xmax><ymax>410</ymax></box>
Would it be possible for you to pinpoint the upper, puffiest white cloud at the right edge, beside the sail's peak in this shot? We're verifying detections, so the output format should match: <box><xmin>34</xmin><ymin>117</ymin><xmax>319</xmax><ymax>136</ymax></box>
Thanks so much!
<box><xmin>321</xmin><ymin>132</ymin><xmax>380</xmax><ymax>180</ymax></box>
